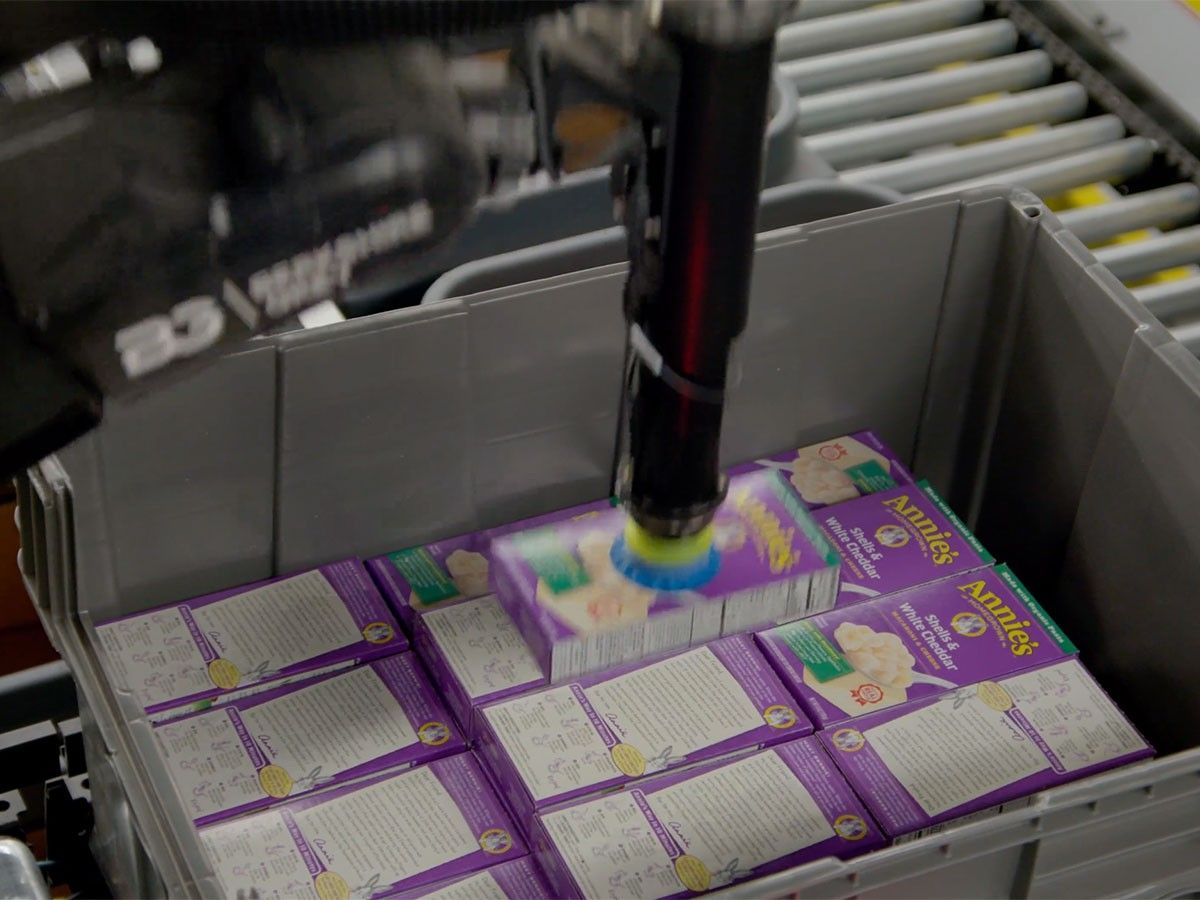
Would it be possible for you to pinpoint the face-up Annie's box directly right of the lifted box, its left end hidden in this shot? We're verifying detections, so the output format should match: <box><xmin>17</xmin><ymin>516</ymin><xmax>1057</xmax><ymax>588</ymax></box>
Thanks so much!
<box><xmin>814</xmin><ymin>481</ymin><xmax>995</xmax><ymax>604</ymax></box>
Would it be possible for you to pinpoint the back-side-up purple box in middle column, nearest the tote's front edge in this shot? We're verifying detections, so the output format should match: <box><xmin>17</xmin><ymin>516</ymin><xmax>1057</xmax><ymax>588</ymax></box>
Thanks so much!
<box><xmin>533</xmin><ymin>738</ymin><xmax>883</xmax><ymax>900</ymax></box>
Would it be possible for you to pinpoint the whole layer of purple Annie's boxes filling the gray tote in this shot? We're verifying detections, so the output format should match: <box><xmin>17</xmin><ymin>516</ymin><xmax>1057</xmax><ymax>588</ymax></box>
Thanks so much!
<box><xmin>97</xmin><ymin>432</ymin><xmax>1152</xmax><ymax>898</ymax></box>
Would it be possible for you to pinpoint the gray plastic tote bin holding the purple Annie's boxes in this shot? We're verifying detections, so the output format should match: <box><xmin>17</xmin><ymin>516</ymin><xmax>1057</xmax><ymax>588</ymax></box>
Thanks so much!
<box><xmin>23</xmin><ymin>188</ymin><xmax>1200</xmax><ymax>898</ymax></box>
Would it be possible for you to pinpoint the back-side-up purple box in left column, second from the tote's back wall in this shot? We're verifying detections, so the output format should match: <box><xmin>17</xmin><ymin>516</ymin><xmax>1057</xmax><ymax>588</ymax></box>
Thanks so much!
<box><xmin>155</xmin><ymin>653</ymin><xmax>467</xmax><ymax>826</ymax></box>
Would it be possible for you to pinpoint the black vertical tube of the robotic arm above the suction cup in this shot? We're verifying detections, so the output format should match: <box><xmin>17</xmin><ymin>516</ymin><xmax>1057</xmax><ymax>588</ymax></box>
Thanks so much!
<box><xmin>623</xmin><ymin>28</ymin><xmax>774</xmax><ymax>538</ymax></box>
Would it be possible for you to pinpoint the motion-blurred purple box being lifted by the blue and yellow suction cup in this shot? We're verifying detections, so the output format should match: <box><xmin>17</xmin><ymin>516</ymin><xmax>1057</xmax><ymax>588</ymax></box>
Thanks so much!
<box><xmin>492</xmin><ymin>470</ymin><xmax>838</xmax><ymax>683</ymax></box>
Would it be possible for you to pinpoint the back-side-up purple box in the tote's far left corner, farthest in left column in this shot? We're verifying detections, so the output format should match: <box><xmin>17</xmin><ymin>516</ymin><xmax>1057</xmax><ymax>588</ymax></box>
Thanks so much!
<box><xmin>96</xmin><ymin>559</ymin><xmax>408</xmax><ymax>721</ymax></box>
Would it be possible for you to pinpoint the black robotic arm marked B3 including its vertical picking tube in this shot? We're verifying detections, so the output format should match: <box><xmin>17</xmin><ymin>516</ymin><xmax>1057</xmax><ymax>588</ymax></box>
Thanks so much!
<box><xmin>0</xmin><ymin>0</ymin><xmax>791</xmax><ymax>549</ymax></box>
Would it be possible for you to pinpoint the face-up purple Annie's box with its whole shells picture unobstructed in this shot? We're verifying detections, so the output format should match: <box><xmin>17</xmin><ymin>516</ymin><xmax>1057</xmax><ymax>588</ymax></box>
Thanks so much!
<box><xmin>757</xmin><ymin>565</ymin><xmax>1076</xmax><ymax>728</ymax></box>
